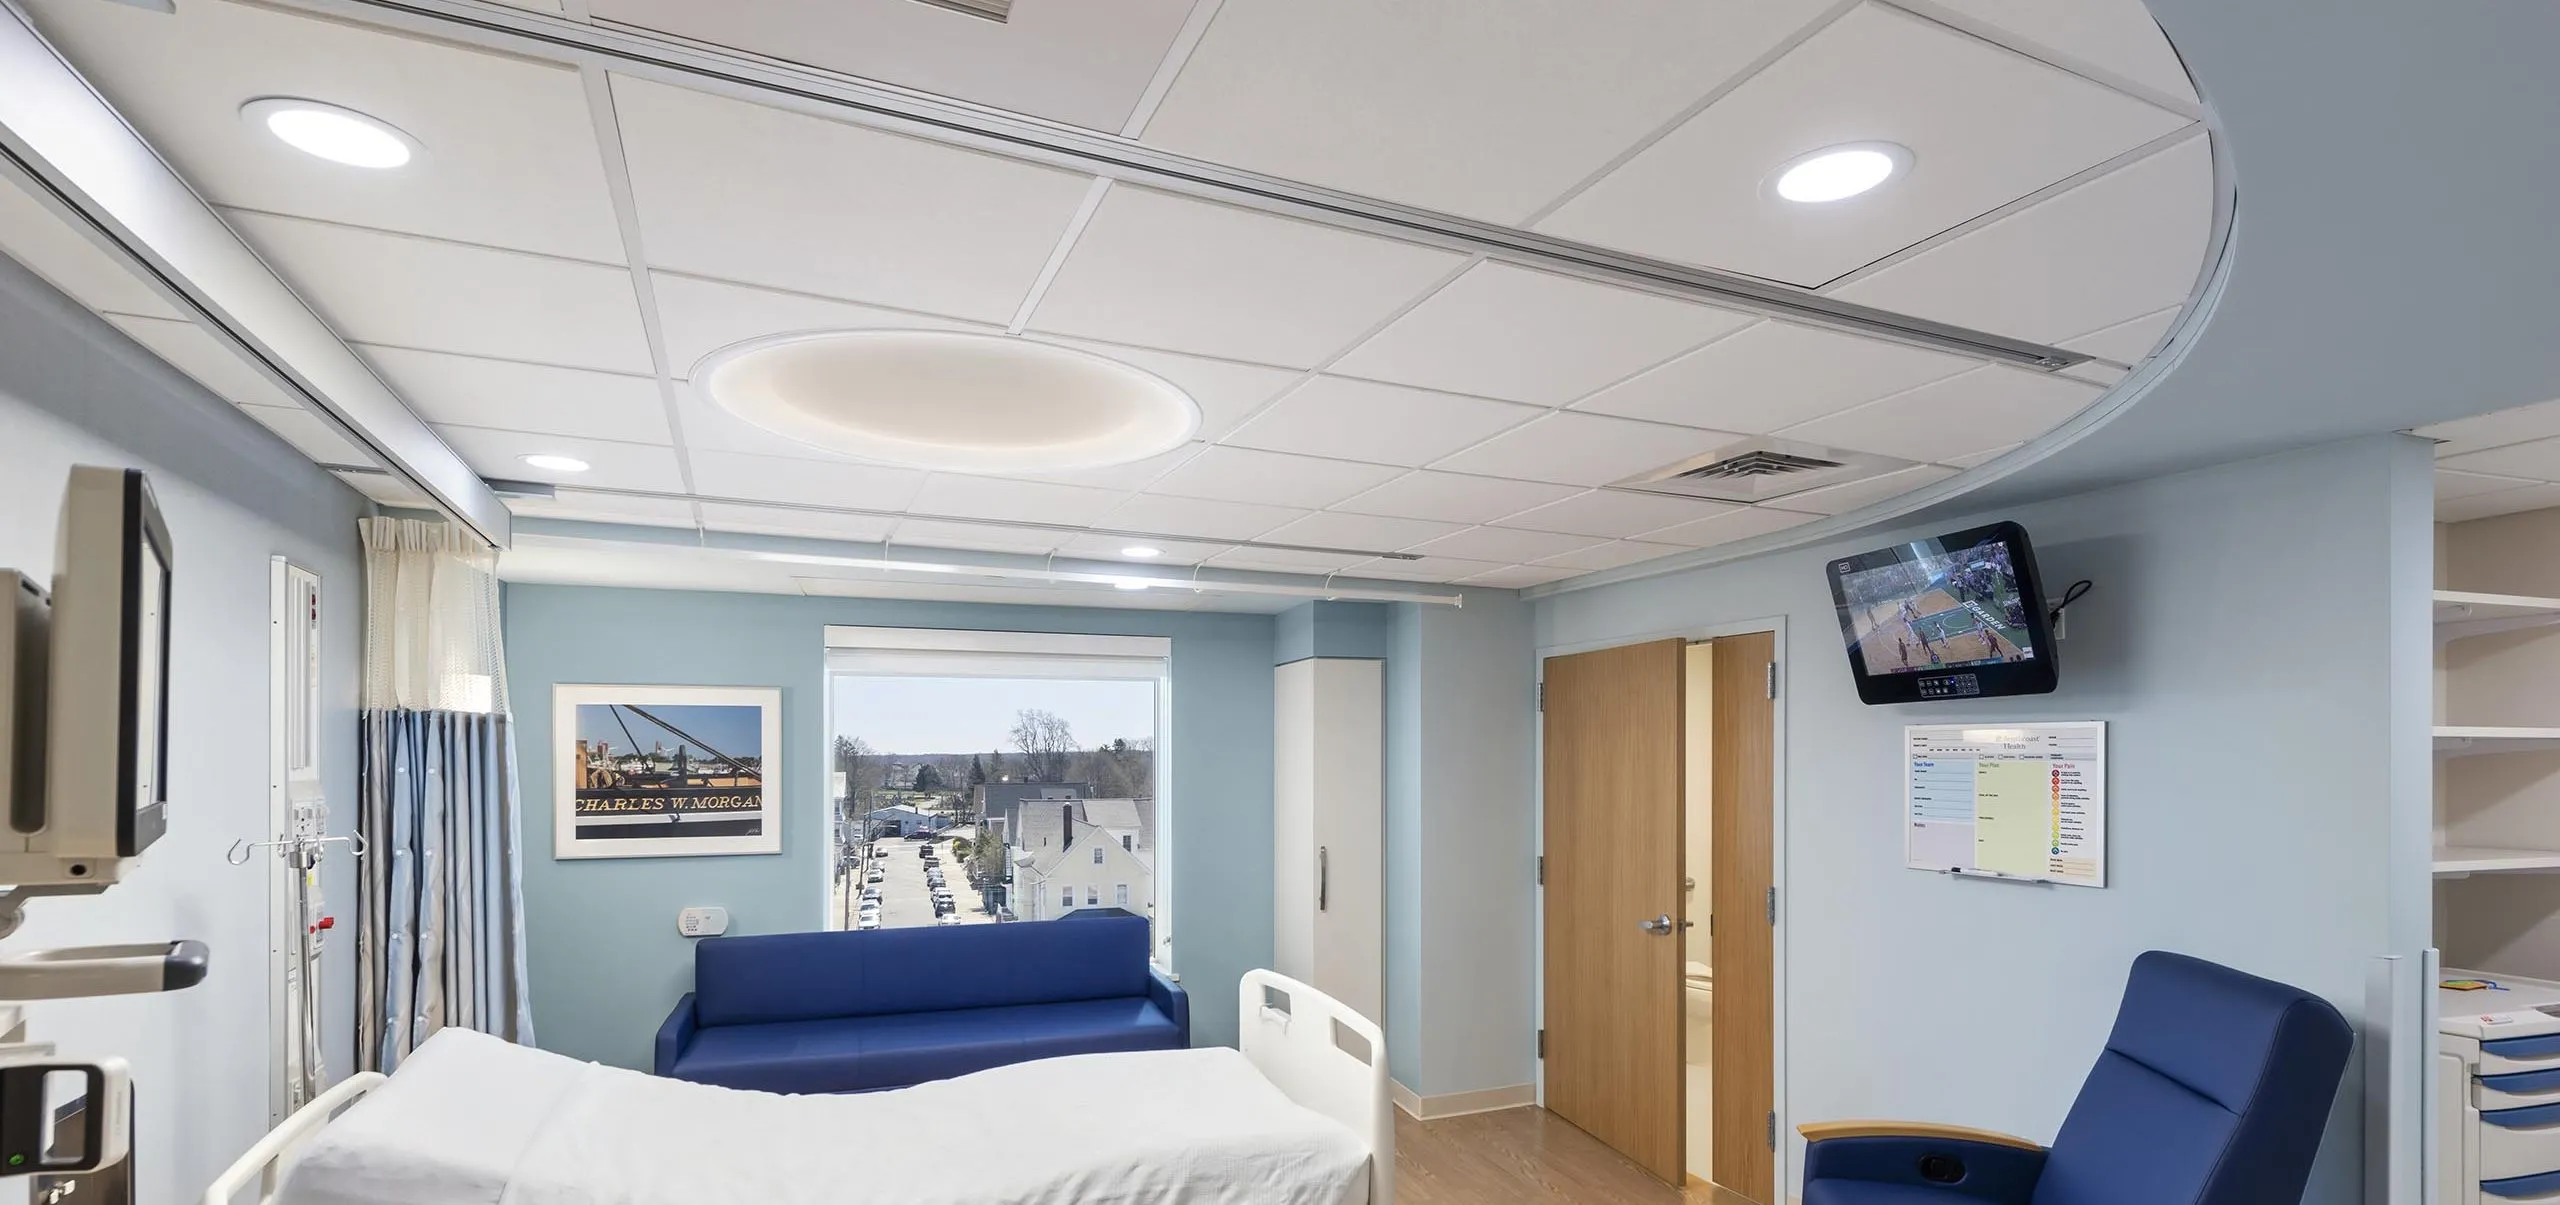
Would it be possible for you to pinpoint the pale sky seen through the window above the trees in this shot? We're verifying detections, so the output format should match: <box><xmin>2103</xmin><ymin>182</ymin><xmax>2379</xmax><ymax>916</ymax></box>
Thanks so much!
<box><xmin>835</xmin><ymin>675</ymin><xmax>1155</xmax><ymax>752</ymax></box>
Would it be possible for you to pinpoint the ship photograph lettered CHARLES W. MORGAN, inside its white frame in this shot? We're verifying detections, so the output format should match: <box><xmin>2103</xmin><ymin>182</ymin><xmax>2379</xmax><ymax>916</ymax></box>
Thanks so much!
<box><xmin>568</xmin><ymin>704</ymin><xmax>765</xmax><ymax>842</ymax></box>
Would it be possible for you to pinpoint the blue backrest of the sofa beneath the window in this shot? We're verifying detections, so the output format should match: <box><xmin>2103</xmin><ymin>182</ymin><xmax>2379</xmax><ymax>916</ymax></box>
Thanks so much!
<box><xmin>694</xmin><ymin>916</ymin><xmax>1147</xmax><ymax>1026</ymax></box>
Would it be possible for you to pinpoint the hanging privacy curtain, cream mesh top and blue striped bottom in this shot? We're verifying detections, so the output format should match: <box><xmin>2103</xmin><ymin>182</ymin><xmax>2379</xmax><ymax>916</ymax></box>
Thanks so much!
<box><xmin>356</xmin><ymin>519</ymin><xmax>532</xmax><ymax>1072</ymax></box>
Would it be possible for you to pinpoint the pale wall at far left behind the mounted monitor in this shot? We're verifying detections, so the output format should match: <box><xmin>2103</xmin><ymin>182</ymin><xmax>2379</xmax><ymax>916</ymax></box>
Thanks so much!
<box><xmin>0</xmin><ymin>258</ymin><xmax>366</xmax><ymax>1205</ymax></box>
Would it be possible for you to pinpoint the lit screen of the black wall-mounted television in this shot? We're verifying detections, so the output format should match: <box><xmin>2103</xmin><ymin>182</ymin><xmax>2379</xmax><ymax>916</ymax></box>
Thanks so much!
<box><xmin>1841</xmin><ymin>540</ymin><xmax>2035</xmax><ymax>673</ymax></box>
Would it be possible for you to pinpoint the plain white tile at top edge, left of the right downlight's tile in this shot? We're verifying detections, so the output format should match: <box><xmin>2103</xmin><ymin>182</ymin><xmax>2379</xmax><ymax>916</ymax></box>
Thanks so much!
<box><xmin>1147</xmin><ymin>0</ymin><xmax>1828</xmax><ymax>225</ymax></box>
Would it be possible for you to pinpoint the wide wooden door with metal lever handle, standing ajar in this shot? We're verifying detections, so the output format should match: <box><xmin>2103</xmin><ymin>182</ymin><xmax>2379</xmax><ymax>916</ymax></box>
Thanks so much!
<box><xmin>1544</xmin><ymin>640</ymin><xmax>1687</xmax><ymax>1185</ymax></box>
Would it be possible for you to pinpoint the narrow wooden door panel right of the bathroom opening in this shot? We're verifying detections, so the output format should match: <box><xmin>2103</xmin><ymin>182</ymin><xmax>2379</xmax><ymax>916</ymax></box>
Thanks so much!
<box><xmin>1708</xmin><ymin>632</ymin><xmax>1784</xmax><ymax>1205</ymax></box>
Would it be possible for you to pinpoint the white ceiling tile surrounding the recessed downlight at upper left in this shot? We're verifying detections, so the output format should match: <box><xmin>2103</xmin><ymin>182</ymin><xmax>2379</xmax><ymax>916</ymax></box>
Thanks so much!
<box><xmin>36</xmin><ymin>0</ymin><xmax>625</xmax><ymax>264</ymax></box>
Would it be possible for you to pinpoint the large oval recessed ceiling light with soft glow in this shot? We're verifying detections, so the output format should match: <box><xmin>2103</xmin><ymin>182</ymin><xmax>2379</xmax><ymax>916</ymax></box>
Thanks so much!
<box><xmin>694</xmin><ymin>330</ymin><xmax>1201</xmax><ymax>473</ymax></box>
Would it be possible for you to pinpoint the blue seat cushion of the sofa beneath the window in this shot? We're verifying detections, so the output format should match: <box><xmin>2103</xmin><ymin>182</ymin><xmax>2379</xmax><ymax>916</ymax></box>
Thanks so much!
<box><xmin>673</xmin><ymin>995</ymin><xmax>1183</xmax><ymax>1092</ymax></box>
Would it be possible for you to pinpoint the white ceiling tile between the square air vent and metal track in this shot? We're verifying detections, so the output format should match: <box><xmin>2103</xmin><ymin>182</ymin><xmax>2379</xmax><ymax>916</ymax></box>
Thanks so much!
<box><xmin>1574</xmin><ymin>322</ymin><xmax>1981</xmax><ymax>435</ymax></box>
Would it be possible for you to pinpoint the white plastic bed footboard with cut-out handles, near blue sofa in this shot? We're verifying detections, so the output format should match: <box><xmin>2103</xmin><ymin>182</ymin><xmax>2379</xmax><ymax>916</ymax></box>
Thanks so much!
<box><xmin>1236</xmin><ymin>970</ymin><xmax>1395</xmax><ymax>1205</ymax></box>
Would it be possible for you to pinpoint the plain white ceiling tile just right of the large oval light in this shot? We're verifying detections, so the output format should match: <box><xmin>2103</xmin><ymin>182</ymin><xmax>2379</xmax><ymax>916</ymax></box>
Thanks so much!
<box><xmin>1226</xmin><ymin>376</ymin><xmax>1544</xmax><ymax>466</ymax></box>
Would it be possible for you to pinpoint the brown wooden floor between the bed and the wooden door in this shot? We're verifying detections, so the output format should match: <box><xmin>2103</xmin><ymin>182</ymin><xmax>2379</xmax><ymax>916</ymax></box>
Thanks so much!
<box><xmin>1395</xmin><ymin>1108</ymin><xmax>1751</xmax><ymax>1205</ymax></box>
